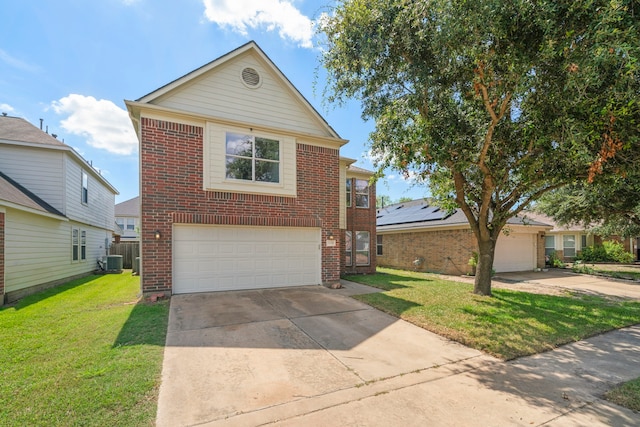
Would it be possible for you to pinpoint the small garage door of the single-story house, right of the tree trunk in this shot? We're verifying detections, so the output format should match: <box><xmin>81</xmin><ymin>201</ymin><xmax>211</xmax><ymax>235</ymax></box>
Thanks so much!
<box><xmin>493</xmin><ymin>233</ymin><xmax>537</xmax><ymax>273</ymax></box>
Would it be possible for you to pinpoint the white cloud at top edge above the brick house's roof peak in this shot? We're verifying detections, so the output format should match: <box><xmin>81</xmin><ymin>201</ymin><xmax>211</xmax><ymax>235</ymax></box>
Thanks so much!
<box><xmin>202</xmin><ymin>0</ymin><xmax>314</xmax><ymax>48</ymax></box>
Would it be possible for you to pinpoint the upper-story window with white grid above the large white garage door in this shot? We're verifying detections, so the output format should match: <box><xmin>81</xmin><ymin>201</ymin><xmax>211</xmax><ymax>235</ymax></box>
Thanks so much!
<box><xmin>226</xmin><ymin>133</ymin><xmax>280</xmax><ymax>183</ymax></box>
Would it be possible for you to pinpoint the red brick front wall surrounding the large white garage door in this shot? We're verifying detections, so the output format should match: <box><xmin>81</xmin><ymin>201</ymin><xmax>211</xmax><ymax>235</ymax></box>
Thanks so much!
<box><xmin>140</xmin><ymin>118</ymin><xmax>340</xmax><ymax>293</ymax></box>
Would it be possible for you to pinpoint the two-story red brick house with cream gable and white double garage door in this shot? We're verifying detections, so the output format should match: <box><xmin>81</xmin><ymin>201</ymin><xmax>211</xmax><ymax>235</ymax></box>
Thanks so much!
<box><xmin>126</xmin><ymin>42</ymin><xmax>375</xmax><ymax>294</ymax></box>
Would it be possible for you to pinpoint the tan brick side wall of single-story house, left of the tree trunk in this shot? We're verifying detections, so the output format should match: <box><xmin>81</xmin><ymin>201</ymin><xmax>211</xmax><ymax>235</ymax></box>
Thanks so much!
<box><xmin>378</xmin><ymin>230</ymin><xmax>478</xmax><ymax>275</ymax></box>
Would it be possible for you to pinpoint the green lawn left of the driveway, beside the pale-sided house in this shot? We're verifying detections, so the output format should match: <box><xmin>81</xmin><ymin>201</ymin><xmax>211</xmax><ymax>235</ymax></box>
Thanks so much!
<box><xmin>0</xmin><ymin>273</ymin><xmax>169</xmax><ymax>426</ymax></box>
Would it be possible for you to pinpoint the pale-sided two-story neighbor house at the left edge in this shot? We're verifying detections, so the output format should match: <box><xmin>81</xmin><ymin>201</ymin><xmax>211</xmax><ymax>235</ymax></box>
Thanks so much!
<box><xmin>0</xmin><ymin>116</ymin><xmax>118</xmax><ymax>303</ymax></box>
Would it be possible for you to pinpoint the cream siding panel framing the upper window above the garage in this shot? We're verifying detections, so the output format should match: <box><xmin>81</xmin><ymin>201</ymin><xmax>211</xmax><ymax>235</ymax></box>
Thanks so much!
<box><xmin>203</xmin><ymin>122</ymin><xmax>297</xmax><ymax>197</ymax></box>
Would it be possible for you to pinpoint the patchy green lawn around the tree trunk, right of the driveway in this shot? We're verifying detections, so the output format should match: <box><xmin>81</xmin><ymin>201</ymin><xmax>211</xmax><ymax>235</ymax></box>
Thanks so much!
<box><xmin>346</xmin><ymin>268</ymin><xmax>640</xmax><ymax>360</ymax></box>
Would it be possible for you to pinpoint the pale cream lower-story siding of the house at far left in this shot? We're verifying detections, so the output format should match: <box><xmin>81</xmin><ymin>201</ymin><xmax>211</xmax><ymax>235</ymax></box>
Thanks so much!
<box><xmin>5</xmin><ymin>209</ymin><xmax>111</xmax><ymax>292</ymax></box>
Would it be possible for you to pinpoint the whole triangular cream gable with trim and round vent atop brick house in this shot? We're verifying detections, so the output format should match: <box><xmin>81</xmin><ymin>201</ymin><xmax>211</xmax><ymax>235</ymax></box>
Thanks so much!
<box><xmin>137</xmin><ymin>41</ymin><xmax>340</xmax><ymax>139</ymax></box>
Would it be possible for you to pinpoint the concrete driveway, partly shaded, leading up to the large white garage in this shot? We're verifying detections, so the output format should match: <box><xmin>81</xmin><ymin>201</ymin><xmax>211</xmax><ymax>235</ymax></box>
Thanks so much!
<box><xmin>157</xmin><ymin>286</ymin><xmax>486</xmax><ymax>426</ymax></box>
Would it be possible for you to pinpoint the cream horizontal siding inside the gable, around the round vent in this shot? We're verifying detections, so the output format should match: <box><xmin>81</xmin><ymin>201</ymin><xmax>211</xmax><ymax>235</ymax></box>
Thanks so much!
<box><xmin>153</xmin><ymin>54</ymin><xmax>331</xmax><ymax>136</ymax></box>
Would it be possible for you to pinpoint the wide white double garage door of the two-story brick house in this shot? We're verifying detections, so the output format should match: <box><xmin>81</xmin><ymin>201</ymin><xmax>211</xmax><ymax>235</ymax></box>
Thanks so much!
<box><xmin>173</xmin><ymin>224</ymin><xmax>321</xmax><ymax>294</ymax></box>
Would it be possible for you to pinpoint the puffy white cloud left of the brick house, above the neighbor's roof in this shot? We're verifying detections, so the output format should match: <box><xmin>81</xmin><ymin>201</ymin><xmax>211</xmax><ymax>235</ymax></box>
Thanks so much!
<box><xmin>51</xmin><ymin>93</ymin><xmax>138</xmax><ymax>155</ymax></box>
